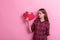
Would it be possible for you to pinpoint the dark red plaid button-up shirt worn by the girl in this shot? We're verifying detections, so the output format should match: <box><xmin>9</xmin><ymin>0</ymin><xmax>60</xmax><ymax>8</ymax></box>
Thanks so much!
<box><xmin>31</xmin><ymin>19</ymin><xmax>50</xmax><ymax>40</ymax></box>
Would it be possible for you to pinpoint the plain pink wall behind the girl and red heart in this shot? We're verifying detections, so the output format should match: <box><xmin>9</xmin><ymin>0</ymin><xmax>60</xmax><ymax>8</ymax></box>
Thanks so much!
<box><xmin>0</xmin><ymin>0</ymin><xmax>60</xmax><ymax>40</ymax></box>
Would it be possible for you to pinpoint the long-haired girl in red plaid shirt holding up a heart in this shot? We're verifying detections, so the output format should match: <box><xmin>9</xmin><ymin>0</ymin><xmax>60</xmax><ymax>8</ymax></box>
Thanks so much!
<box><xmin>25</xmin><ymin>8</ymin><xmax>50</xmax><ymax>40</ymax></box>
